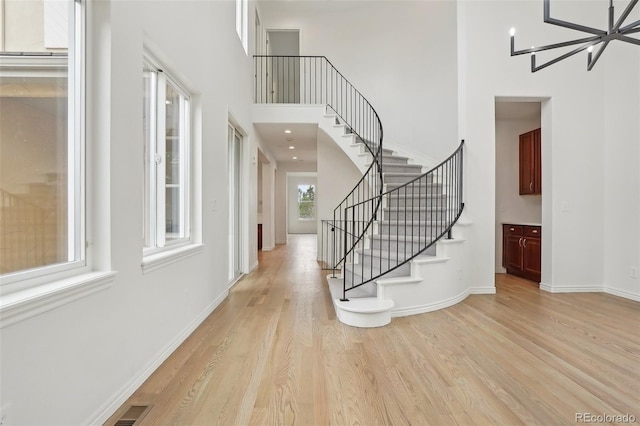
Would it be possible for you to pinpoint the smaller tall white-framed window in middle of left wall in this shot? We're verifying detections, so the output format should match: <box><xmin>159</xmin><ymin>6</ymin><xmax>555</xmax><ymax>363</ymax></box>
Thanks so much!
<box><xmin>142</xmin><ymin>55</ymin><xmax>191</xmax><ymax>250</ymax></box>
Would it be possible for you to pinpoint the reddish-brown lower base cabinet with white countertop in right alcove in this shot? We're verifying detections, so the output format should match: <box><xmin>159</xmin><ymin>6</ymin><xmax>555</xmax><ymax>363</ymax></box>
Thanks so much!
<box><xmin>502</xmin><ymin>224</ymin><xmax>542</xmax><ymax>283</ymax></box>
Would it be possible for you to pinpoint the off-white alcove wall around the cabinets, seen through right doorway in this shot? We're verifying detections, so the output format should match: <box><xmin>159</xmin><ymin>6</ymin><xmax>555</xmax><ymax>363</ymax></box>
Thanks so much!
<box><xmin>495</xmin><ymin>106</ymin><xmax>542</xmax><ymax>272</ymax></box>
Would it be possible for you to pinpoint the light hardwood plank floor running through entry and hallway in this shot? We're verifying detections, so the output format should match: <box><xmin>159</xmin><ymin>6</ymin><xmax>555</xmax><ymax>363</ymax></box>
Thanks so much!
<box><xmin>107</xmin><ymin>236</ymin><xmax>640</xmax><ymax>425</ymax></box>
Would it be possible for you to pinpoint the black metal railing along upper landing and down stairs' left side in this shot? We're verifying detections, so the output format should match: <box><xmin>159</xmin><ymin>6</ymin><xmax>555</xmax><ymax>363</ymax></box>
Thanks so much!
<box><xmin>254</xmin><ymin>55</ymin><xmax>383</xmax><ymax>274</ymax></box>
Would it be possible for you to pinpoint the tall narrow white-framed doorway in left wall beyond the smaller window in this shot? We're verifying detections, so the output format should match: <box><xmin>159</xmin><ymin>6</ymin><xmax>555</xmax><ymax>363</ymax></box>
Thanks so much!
<box><xmin>227</xmin><ymin>123</ymin><xmax>244</xmax><ymax>283</ymax></box>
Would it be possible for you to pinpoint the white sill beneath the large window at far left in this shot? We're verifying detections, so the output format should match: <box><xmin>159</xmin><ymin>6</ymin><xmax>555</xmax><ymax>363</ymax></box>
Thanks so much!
<box><xmin>0</xmin><ymin>271</ymin><xmax>116</xmax><ymax>328</ymax></box>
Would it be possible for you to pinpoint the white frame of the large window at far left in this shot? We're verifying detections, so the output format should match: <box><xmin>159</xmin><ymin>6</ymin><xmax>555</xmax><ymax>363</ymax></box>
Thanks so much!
<box><xmin>0</xmin><ymin>0</ymin><xmax>86</xmax><ymax>293</ymax></box>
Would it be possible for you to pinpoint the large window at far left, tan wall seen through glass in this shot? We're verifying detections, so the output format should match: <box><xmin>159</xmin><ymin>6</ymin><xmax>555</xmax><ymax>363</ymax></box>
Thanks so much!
<box><xmin>0</xmin><ymin>0</ymin><xmax>85</xmax><ymax>283</ymax></box>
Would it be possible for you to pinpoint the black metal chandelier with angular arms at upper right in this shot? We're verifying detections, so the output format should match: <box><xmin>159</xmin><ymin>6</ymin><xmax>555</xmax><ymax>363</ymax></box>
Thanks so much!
<box><xmin>509</xmin><ymin>0</ymin><xmax>640</xmax><ymax>72</ymax></box>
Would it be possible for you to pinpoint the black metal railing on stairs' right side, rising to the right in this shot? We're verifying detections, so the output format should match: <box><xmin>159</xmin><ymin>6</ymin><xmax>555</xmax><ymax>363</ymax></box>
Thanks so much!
<box><xmin>342</xmin><ymin>141</ymin><xmax>464</xmax><ymax>301</ymax></box>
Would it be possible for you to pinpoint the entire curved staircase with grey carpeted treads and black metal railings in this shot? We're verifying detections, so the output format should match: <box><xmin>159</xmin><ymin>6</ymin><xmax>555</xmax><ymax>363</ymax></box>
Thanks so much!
<box><xmin>254</xmin><ymin>55</ymin><xmax>471</xmax><ymax>327</ymax></box>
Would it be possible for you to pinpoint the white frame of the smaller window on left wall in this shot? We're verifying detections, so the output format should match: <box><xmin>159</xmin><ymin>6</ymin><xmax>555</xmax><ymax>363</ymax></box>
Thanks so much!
<box><xmin>143</xmin><ymin>52</ymin><xmax>194</xmax><ymax>258</ymax></box>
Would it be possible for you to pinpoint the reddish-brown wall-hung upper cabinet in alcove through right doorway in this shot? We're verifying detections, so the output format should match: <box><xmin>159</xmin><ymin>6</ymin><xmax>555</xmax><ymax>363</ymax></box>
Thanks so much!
<box><xmin>520</xmin><ymin>129</ymin><xmax>542</xmax><ymax>195</ymax></box>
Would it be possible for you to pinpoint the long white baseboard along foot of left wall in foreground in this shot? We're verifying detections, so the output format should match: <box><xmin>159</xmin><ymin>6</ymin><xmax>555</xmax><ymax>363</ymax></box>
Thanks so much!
<box><xmin>83</xmin><ymin>291</ymin><xmax>229</xmax><ymax>425</ymax></box>
